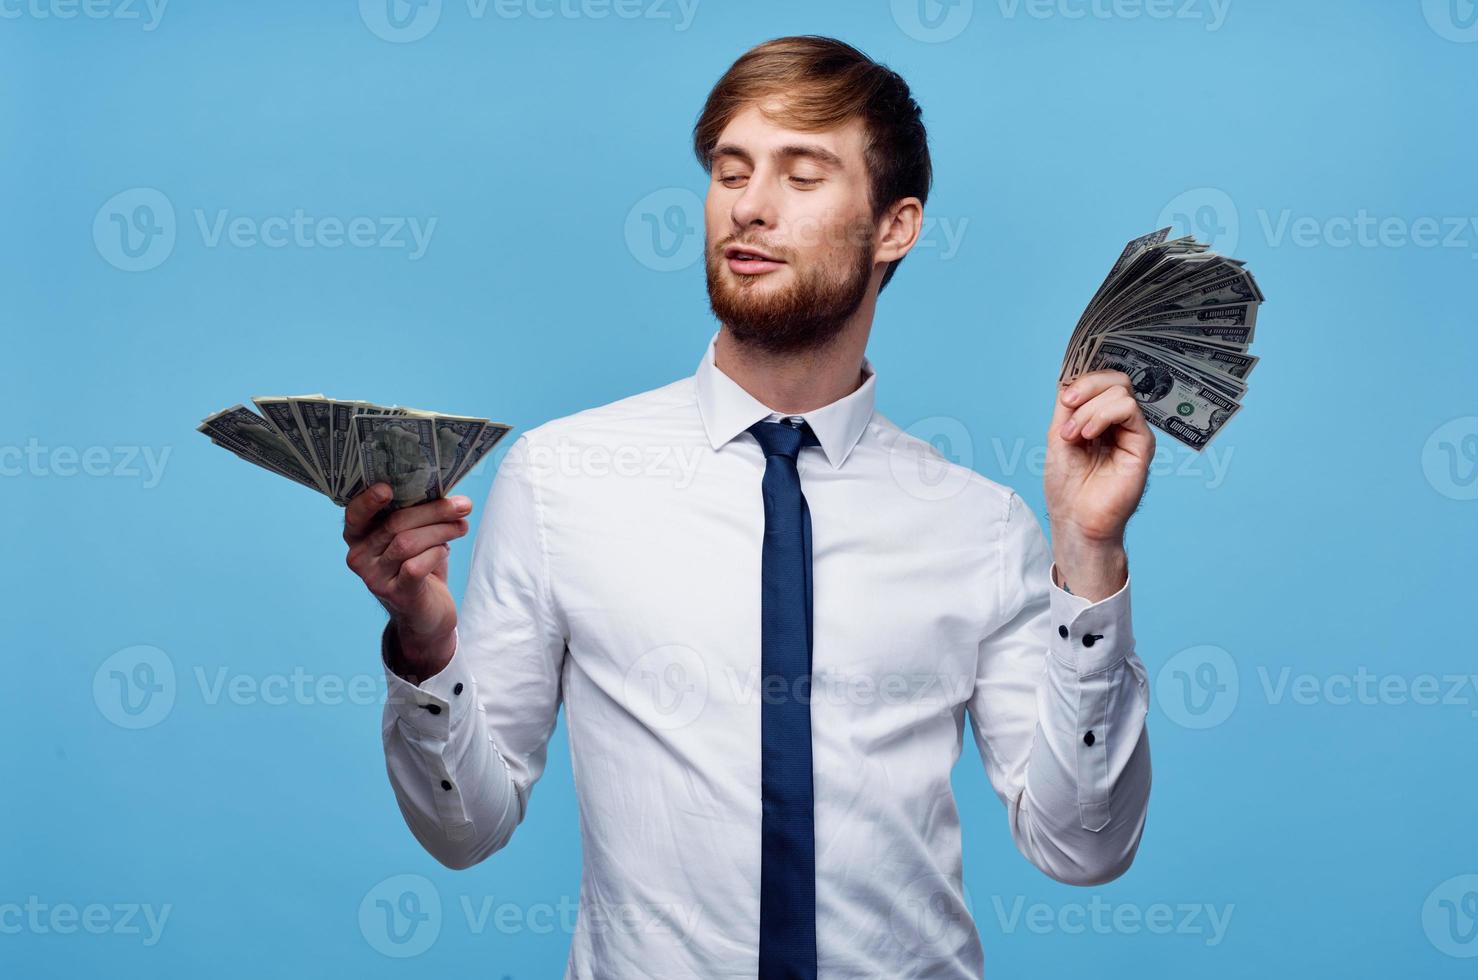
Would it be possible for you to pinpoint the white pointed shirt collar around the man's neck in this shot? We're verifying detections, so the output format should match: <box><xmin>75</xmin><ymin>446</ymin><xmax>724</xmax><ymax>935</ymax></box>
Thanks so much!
<box><xmin>693</xmin><ymin>331</ymin><xmax>876</xmax><ymax>467</ymax></box>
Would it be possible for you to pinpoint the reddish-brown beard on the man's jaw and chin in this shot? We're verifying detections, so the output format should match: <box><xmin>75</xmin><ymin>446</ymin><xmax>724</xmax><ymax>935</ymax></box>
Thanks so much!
<box><xmin>705</xmin><ymin>226</ymin><xmax>873</xmax><ymax>353</ymax></box>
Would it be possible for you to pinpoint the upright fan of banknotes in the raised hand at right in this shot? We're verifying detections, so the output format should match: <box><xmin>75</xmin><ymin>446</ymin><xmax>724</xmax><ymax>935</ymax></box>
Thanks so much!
<box><xmin>1058</xmin><ymin>228</ymin><xmax>1262</xmax><ymax>451</ymax></box>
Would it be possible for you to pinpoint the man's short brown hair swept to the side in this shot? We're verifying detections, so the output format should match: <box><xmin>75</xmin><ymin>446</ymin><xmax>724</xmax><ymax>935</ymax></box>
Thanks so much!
<box><xmin>693</xmin><ymin>34</ymin><xmax>934</xmax><ymax>293</ymax></box>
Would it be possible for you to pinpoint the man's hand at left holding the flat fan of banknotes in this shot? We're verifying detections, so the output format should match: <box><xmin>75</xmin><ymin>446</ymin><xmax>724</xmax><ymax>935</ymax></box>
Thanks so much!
<box><xmin>344</xmin><ymin>483</ymin><xmax>471</xmax><ymax>681</ymax></box>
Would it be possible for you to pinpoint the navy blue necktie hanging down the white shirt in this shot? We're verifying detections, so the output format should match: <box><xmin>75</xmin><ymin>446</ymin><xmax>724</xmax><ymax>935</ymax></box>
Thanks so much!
<box><xmin>749</xmin><ymin>420</ymin><xmax>820</xmax><ymax>980</ymax></box>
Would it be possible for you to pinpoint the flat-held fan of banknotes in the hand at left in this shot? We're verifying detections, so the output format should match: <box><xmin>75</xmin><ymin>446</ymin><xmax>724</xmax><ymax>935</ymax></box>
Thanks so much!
<box><xmin>198</xmin><ymin>395</ymin><xmax>511</xmax><ymax>508</ymax></box>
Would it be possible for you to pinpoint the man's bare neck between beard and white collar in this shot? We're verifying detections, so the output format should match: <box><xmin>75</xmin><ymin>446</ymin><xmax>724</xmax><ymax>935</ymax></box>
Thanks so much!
<box><xmin>714</xmin><ymin>318</ymin><xmax>872</xmax><ymax>415</ymax></box>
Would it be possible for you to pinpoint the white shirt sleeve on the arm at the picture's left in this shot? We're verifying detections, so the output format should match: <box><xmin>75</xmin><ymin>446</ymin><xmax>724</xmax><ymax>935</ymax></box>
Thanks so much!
<box><xmin>381</xmin><ymin>436</ymin><xmax>566</xmax><ymax>868</ymax></box>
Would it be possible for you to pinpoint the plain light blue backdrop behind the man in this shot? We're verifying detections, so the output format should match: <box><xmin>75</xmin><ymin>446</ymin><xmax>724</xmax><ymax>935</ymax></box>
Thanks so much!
<box><xmin>0</xmin><ymin>0</ymin><xmax>1478</xmax><ymax>980</ymax></box>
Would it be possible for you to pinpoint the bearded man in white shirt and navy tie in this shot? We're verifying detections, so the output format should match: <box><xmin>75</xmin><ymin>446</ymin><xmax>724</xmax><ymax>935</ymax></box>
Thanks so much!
<box><xmin>344</xmin><ymin>37</ymin><xmax>1154</xmax><ymax>980</ymax></box>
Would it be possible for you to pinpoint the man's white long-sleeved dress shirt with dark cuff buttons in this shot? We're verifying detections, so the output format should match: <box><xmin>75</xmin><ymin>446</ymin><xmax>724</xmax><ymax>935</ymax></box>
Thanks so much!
<box><xmin>383</xmin><ymin>334</ymin><xmax>1150</xmax><ymax>980</ymax></box>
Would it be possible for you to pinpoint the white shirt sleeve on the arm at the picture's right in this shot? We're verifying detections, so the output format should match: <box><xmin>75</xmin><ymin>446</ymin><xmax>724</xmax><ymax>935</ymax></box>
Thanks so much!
<box><xmin>968</xmin><ymin>494</ymin><xmax>1150</xmax><ymax>885</ymax></box>
